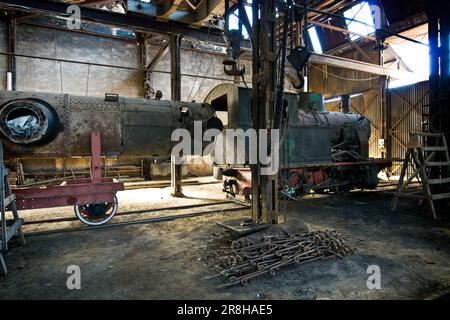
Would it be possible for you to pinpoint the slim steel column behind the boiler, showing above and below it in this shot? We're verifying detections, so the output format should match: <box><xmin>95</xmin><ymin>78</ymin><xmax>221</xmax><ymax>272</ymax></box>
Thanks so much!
<box><xmin>169</xmin><ymin>35</ymin><xmax>183</xmax><ymax>198</ymax></box>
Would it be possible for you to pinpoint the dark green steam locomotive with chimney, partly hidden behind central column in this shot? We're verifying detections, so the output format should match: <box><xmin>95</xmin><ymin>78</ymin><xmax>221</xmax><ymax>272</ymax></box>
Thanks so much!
<box><xmin>205</xmin><ymin>84</ymin><xmax>392</xmax><ymax>199</ymax></box>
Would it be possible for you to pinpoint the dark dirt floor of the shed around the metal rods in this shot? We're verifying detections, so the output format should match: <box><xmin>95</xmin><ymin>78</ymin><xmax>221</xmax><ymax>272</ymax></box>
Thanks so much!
<box><xmin>0</xmin><ymin>180</ymin><xmax>450</xmax><ymax>300</ymax></box>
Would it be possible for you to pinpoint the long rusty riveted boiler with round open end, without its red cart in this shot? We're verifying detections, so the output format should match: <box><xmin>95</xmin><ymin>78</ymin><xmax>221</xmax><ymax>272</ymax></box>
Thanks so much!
<box><xmin>0</xmin><ymin>91</ymin><xmax>223</xmax><ymax>158</ymax></box>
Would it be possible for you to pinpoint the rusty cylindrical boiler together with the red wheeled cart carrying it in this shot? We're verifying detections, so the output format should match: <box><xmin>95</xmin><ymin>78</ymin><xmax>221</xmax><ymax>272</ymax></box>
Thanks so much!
<box><xmin>0</xmin><ymin>91</ymin><xmax>222</xmax><ymax>225</ymax></box>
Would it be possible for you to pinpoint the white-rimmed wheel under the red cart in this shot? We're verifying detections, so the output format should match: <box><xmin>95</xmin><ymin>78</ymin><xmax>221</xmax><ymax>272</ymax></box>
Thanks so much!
<box><xmin>74</xmin><ymin>196</ymin><xmax>119</xmax><ymax>226</ymax></box>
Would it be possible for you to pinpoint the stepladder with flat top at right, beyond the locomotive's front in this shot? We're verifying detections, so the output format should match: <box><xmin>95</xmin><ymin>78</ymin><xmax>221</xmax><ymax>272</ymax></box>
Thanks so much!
<box><xmin>391</xmin><ymin>132</ymin><xmax>450</xmax><ymax>219</ymax></box>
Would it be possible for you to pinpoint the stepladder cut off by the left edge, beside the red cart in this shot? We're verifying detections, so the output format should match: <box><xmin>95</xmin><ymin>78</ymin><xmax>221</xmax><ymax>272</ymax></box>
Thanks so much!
<box><xmin>0</xmin><ymin>140</ymin><xmax>25</xmax><ymax>275</ymax></box>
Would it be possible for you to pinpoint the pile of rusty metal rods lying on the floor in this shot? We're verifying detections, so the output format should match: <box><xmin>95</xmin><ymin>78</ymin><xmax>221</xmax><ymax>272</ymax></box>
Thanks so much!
<box><xmin>203</xmin><ymin>230</ymin><xmax>356</xmax><ymax>288</ymax></box>
